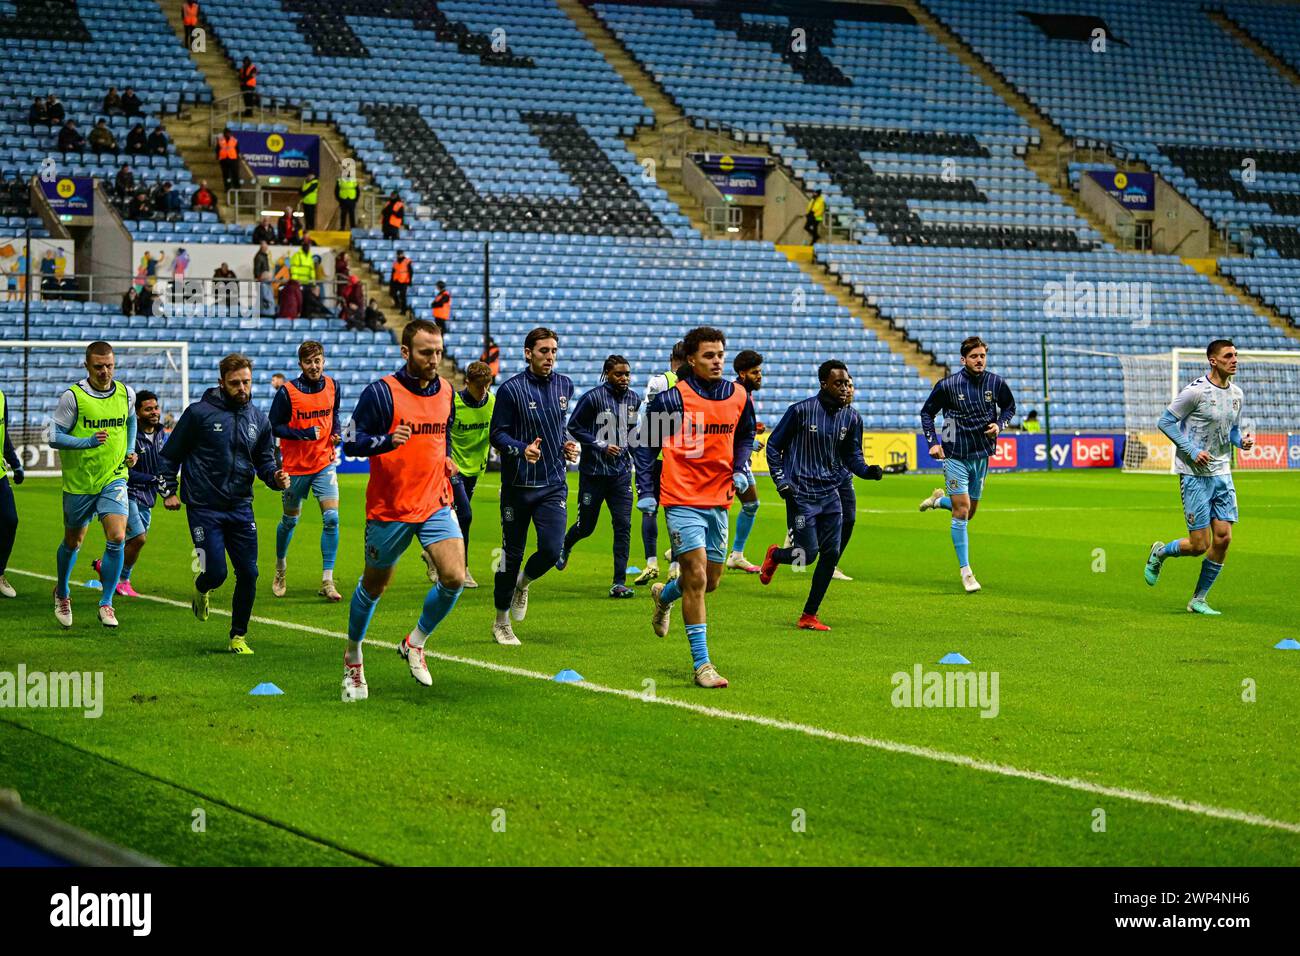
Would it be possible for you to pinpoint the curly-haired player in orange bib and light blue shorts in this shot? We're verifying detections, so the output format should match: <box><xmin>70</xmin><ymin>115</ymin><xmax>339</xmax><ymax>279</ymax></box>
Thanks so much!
<box><xmin>633</xmin><ymin>326</ymin><xmax>754</xmax><ymax>687</ymax></box>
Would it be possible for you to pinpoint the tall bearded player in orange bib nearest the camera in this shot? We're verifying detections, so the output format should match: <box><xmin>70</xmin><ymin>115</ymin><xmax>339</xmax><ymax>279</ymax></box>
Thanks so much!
<box><xmin>343</xmin><ymin>319</ymin><xmax>465</xmax><ymax>701</ymax></box>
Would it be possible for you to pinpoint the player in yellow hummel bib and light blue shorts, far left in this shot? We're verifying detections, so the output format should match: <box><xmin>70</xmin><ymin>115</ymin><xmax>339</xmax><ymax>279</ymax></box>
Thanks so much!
<box><xmin>49</xmin><ymin>342</ymin><xmax>137</xmax><ymax>628</ymax></box>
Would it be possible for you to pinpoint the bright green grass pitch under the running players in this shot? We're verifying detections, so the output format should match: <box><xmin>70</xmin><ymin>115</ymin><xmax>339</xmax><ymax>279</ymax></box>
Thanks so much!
<box><xmin>0</xmin><ymin>472</ymin><xmax>1300</xmax><ymax>865</ymax></box>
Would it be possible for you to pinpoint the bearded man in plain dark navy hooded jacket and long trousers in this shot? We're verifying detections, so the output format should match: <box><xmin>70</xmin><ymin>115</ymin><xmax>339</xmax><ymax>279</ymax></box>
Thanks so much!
<box><xmin>157</xmin><ymin>352</ymin><xmax>289</xmax><ymax>654</ymax></box>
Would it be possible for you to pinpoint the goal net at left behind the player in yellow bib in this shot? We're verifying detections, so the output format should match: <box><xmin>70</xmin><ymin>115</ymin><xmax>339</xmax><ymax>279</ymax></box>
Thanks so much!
<box><xmin>0</xmin><ymin>338</ymin><xmax>190</xmax><ymax>475</ymax></box>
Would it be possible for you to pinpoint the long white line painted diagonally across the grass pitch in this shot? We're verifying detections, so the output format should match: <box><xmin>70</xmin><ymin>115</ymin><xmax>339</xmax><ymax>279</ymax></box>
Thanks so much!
<box><xmin>9</xmin><ymin>567</ymin><xmax>1300</xmax><ymax>834</ymax></box>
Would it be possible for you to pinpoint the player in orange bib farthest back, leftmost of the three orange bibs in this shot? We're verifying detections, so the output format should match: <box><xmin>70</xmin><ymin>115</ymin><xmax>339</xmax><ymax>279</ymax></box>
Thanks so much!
<box><xmin>268</xmin><ymin>339</ymin><xmax>343</xmax><ymax>601</ymax></box>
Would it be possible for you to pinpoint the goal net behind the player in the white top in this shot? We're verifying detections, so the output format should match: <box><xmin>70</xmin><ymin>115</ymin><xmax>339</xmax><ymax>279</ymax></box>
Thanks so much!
<box><xmin>1119</xmin><ymin>349</ymin><xmax>1300</xmax><ymax>473</ymax></box>
